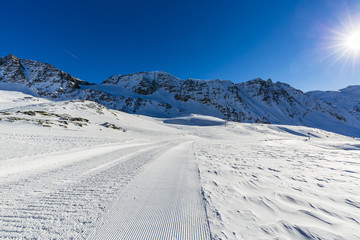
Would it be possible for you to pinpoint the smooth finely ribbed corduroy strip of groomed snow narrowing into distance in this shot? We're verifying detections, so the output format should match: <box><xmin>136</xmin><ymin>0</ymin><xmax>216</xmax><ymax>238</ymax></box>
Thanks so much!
<box><xmin>89</xmin><ymin>141</ymin><xmax>211</xmax><ymax>240</ymax></box>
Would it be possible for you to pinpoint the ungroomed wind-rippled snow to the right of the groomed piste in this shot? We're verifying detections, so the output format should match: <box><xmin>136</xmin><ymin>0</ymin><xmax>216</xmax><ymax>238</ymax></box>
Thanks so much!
<box><xmin>194</xmin><ymin>124</ymin><xmax>360</xmax><ymax>239</ymax></box>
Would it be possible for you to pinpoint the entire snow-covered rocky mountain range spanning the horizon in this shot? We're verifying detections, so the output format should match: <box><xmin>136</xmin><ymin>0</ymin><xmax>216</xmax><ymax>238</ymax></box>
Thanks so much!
<box><xmin>0</xmin><ymin>55</ymin><xmax>360</xmax><ymax>136</ymax></box>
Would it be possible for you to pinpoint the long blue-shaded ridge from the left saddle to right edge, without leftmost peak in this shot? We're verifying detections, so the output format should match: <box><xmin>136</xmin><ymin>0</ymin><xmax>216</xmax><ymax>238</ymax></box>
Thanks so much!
<box><xmin>86</xmin><ymin>72</ymin><xmax>360</xmax><ymax>136</ymax></box>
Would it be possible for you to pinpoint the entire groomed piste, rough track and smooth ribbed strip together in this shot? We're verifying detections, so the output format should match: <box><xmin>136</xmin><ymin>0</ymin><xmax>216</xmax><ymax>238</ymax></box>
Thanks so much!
<box><xmin>0</xmin><ymin>130</ymin><xmax>209</xmax><ymax>239</ymax></box>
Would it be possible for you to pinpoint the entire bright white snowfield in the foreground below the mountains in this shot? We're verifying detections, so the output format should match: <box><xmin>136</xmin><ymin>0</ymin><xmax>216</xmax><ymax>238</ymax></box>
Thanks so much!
<box><xmin>0</xmin><ymin>91</ymin><xmax>360</xmax><ymax>239</ymax></box>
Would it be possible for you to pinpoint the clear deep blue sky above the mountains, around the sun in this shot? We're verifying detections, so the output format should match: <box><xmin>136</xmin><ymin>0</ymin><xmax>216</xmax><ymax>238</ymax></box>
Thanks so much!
<box><xmin>0</xmin><ymin>0</ymin><xmax>360</xmax><ymax>91</ymax></box>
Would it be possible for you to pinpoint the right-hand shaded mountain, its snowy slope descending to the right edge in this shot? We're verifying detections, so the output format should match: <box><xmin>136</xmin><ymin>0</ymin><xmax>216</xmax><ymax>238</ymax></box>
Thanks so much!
<box><xmin>237</xmin><ymin>79</ymin><xmax>360</xmax><ymax>136</ymax></box>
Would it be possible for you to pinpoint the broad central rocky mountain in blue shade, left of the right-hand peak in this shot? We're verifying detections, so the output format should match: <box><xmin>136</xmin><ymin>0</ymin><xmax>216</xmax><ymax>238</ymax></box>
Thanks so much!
<box><xmin>84</xmin><ymin>72</ymin><xmax>260</xmax><ymax>122</ymax></box>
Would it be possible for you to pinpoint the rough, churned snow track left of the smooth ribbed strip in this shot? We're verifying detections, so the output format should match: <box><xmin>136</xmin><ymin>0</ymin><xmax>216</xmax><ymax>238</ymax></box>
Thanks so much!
<box><xmin>0</xmin><ymin>141</ymin><xmax>174</xmax><ymax>239</ymax></box>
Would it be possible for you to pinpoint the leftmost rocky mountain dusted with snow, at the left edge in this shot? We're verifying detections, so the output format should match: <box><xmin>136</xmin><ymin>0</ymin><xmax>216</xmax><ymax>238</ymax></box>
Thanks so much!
<box><xmin>0</xmin><ymin>55</ymin><xmax>89</xmax><ymax>99</ymax></box>
